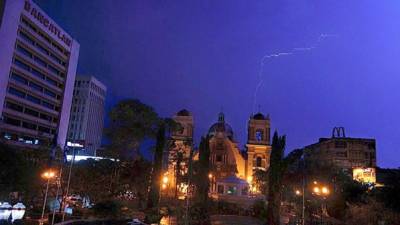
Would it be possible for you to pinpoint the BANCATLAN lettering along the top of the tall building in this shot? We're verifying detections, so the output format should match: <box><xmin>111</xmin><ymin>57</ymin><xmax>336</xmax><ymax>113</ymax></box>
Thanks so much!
<box><xmin>24</xmin><ymin>1</ymin><xmax>72</xmax><ymax>47</ymax></box>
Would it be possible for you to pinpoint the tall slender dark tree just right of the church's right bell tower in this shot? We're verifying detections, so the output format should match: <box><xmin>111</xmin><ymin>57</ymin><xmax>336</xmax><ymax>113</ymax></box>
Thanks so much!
<box><xmin>267</xmin><ymin>131</ymin><xmax>303</xmax><ymax>225</ymax></box>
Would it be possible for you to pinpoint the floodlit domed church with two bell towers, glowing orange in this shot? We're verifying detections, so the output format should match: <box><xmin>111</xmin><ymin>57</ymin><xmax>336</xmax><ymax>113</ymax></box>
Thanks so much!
<box><xmin>162</xmin><ymin>109</ymin><xmax>271</xmax><ymax>202</ymax></box>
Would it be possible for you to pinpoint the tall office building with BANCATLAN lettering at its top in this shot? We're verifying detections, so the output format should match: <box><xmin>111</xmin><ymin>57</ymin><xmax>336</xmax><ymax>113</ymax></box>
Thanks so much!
<box><xmin>0</xmin><ymin>0</ymin><xmax>79</xmax><ymax>148</ymax></box>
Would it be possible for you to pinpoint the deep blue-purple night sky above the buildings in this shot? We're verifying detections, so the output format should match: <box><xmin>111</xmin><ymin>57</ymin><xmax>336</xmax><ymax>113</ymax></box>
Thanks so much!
<box><xmin>36</xmin><ymin>0</ymin><xmax>400</xmax><ymax>167</ymax></box>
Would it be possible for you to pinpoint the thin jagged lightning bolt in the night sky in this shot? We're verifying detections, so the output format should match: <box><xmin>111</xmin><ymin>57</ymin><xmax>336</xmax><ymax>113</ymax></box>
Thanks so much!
<box><xmin>253</xmin><ymin>34</ymin><xmax>339</xmax><ymax>112</ymax></box>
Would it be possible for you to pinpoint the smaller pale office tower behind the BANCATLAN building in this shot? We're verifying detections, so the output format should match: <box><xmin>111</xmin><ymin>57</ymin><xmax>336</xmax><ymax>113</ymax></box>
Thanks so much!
<box><xmin>68</xmin><ymin>76</ymin><xmax>107</xmax><ymax>156</ymax></box>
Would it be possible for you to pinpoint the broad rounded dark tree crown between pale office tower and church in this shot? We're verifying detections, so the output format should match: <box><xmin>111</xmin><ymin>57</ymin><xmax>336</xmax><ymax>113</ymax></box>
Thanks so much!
<box><xmin>106</xmin><ymin>99</ymin><xmax>159</xmax><ymax>160</ymax></box>
